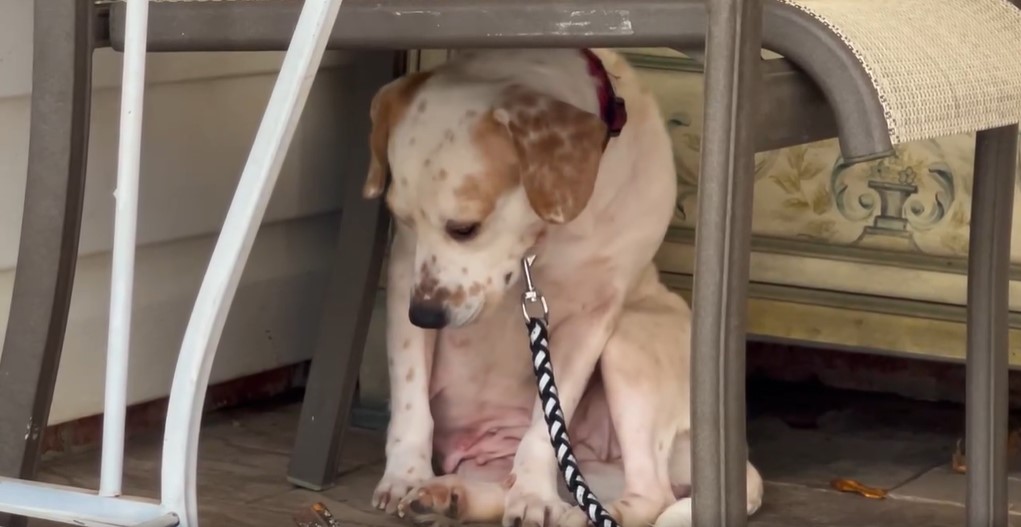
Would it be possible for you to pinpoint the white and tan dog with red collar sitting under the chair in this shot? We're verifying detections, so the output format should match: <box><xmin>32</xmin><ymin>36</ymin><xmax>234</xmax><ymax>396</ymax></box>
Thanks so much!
<box><xmin>363</xmin><ymin>49</ymin><xmax>763</xmax><ymax>527</ymax></box>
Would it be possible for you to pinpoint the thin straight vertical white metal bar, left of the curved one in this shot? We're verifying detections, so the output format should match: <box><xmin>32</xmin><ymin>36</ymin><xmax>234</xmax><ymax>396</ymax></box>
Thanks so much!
<box><xmin>99</xmin><ymin>0</ymin><xmax>149</xmax><ymax>496</ymax></box>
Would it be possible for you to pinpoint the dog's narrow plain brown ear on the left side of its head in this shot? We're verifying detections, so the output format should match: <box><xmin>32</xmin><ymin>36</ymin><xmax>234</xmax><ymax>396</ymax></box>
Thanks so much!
<box><xmin>361</xmin><ymin>71</ymin><xmax>432</xmax><ymax>199</ymax></box>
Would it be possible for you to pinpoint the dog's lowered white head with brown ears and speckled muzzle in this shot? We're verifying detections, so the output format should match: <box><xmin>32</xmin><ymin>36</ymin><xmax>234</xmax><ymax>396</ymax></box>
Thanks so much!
<box><xmin>364</xmin><ymin>73</ymin><xmax>606</xmax><ymax>328</ymax></box>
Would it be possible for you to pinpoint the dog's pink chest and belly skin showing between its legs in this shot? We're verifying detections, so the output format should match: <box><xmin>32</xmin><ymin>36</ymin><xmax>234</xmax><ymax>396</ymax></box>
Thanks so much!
<box><xmin>430</xmin><ymin>313</ymin><xmax>620</xmax><ymax>474</ymax></box>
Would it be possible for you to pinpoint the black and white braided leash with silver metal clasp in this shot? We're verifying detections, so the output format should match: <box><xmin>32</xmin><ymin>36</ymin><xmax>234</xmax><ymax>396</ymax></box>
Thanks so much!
<box><xmin>521</xmin><ymin>255</ymin><xmax>620</xmax><ymax>527</ymax></box>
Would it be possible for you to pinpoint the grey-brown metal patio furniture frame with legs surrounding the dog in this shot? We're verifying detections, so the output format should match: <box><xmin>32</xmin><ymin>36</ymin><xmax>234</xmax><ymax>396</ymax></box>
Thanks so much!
<box><xmin>0</xmin><ymin>0</ymin><xmax>1018</xmax><ymax>527</ymax></box>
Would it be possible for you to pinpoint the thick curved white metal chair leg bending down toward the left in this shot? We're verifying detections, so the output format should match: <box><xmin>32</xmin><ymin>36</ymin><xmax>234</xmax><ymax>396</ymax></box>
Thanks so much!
<box><xmin>161</xmin><ymin>0</ymin><xmax>341</xmax><ymax>527</ymax></box>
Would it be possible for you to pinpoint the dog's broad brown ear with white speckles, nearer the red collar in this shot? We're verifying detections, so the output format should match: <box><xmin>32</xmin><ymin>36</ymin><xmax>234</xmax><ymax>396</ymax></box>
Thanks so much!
<box><xmin>493</xmin><ymin>87</ymin><xmax>606</xmax><ymax>224</ymax></box>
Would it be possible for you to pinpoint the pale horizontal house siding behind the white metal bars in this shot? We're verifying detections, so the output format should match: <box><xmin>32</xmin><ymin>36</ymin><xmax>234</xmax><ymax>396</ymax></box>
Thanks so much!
<box><xmin>0</xmin><ymin>0</ymin><xmax>366</xmax><ymax>424</ymax></box>
